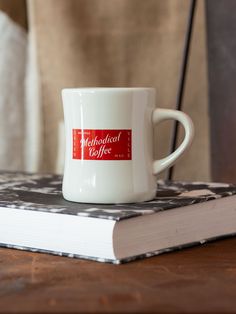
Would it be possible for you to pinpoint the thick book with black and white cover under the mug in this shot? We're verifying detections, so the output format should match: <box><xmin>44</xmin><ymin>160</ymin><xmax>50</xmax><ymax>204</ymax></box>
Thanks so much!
<box><xmin>0</xmin><ymin>172</ymin><xmax>236</xmax><ymax>264</ymax></box>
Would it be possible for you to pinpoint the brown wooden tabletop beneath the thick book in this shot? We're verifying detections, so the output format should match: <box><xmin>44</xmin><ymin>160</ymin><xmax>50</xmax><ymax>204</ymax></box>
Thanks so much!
<box><xmin>0</xmin><ymin>238</ymin><xmax>236</xmax><ymax>313</ymax></box>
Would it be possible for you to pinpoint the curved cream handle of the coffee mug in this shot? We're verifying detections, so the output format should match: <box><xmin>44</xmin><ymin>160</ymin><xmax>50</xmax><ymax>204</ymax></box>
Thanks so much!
<box><xmin>152</xmin><ymin>108</ymin><xmax>194</xmax><ymax>175</ymax></box>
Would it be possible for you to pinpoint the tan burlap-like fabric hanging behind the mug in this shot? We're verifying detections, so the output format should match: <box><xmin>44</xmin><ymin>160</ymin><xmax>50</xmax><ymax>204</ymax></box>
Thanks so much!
<box><xmin>0</xmin><ymin>0</ymin><xmax>209</xmax><ymax>180</ymax></box>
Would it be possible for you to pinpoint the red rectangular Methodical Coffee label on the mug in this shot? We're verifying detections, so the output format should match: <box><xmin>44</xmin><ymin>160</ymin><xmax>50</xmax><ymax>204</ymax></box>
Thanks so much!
<box><xmin>72</xmin><ymin>129</ymin><xmax>132</xmax><ymax>160</ymax></box>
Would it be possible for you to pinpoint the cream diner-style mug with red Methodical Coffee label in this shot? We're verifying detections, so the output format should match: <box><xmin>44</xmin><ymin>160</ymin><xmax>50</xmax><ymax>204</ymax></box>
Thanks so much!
<box><xmin>62</xmin><ymin>88</ymin><xmax>194</xmax><ymax>203</ymax></box>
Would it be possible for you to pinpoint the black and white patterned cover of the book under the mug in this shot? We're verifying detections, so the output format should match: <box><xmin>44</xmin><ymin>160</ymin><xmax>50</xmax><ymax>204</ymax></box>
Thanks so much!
<box><xmin>0</xmin><ymin>172</ymin><xmax>236</xmax><ymax>264</ymax></box>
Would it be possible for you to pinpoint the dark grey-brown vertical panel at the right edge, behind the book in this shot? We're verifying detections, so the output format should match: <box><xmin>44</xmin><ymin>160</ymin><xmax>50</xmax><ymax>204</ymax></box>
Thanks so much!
<box><xmin>206</xmin><ymin>0</ymin><xmax>236</xmax><ymax>182</ymax></box>
